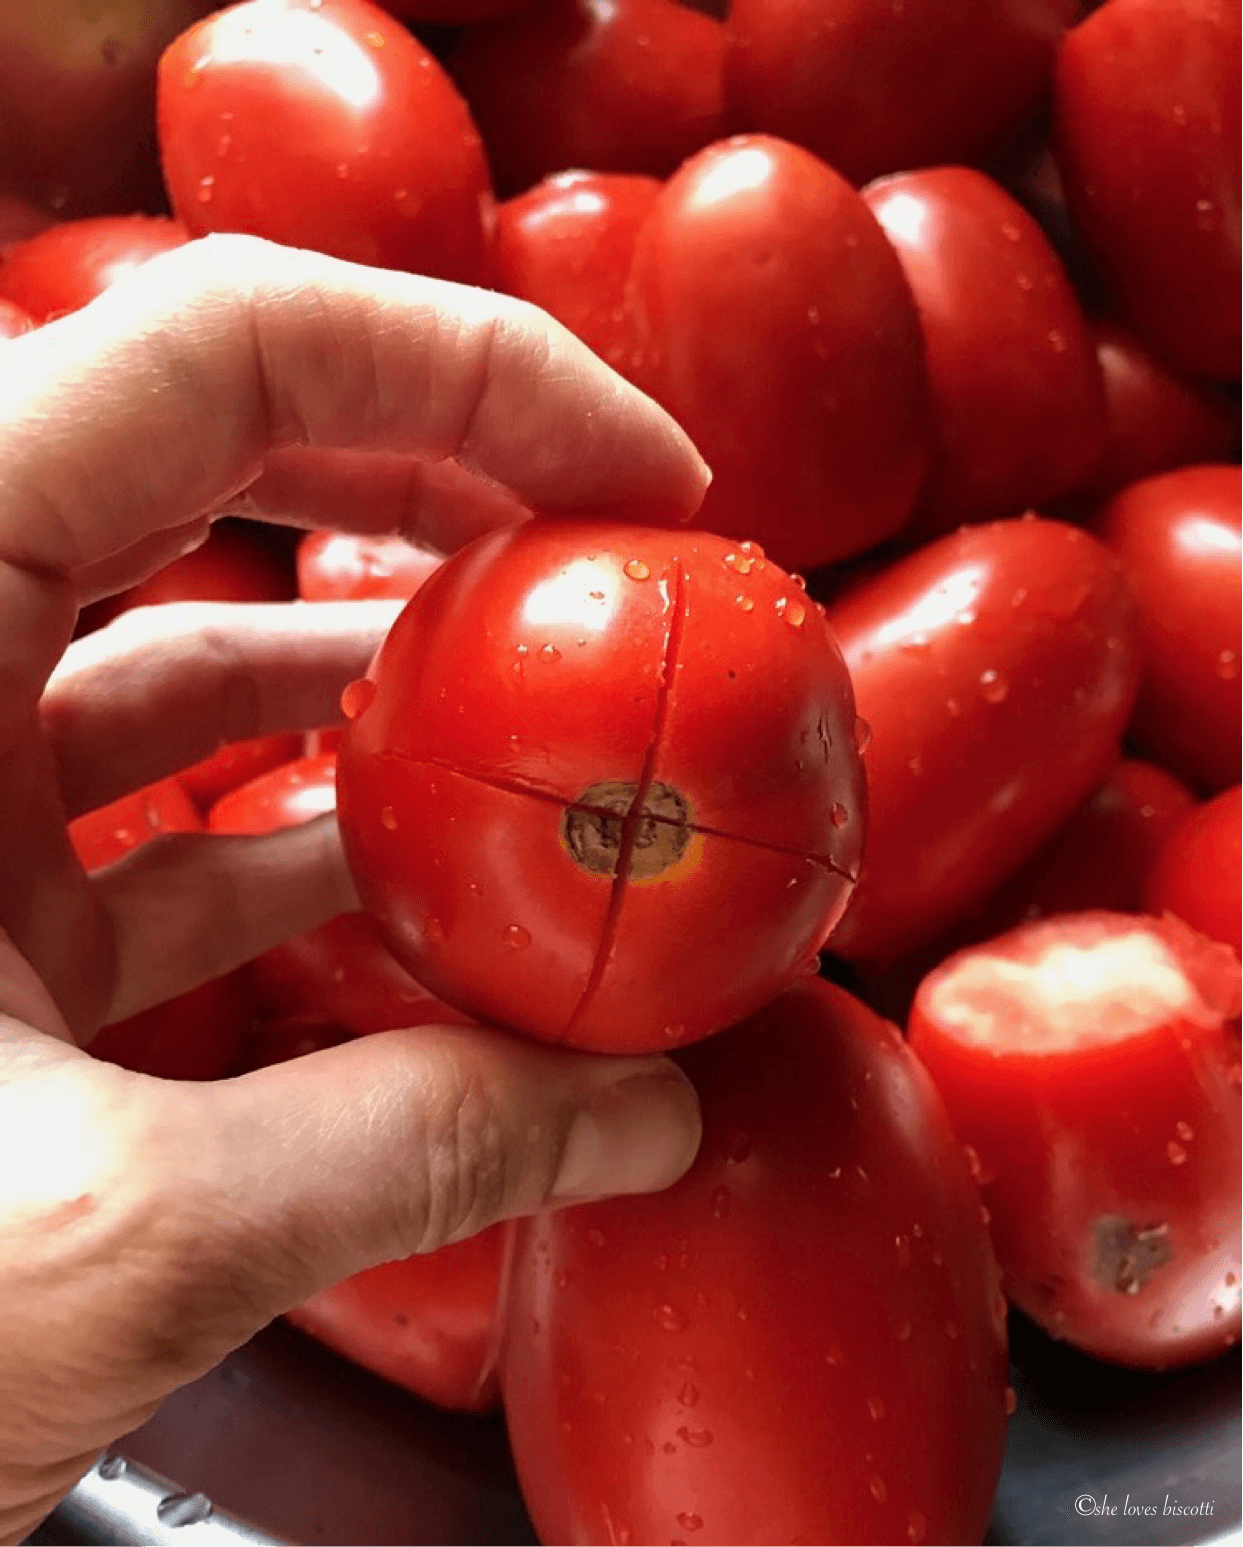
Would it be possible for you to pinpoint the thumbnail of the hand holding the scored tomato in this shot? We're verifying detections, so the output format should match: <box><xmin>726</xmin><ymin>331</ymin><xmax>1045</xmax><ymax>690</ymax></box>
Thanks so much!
<box><xmin>551</xmin><ymin>1063</ymin><xmax>701</xmax><ymax>1202</ymax></box>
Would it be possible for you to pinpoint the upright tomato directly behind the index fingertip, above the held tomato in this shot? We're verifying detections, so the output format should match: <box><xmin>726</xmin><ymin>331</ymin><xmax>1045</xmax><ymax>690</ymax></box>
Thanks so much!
<box><xmin>628</xmin><ymin>138</ymin><xmax>927</xmax><ymax>568</ymax></box>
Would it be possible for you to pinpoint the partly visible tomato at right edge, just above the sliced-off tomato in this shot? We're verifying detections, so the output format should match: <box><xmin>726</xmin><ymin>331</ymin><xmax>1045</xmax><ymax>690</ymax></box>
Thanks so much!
<box><xmin>1147</xmin><ymin>784</ymin><xmax>1243</xmax><ymax>956</ymax></box>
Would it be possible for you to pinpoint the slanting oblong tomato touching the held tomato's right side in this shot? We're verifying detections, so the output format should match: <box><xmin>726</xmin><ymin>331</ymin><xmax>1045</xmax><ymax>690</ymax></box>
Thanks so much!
<box><xmin>828</xmin><ymin>517</ymin><xmax>1139</xmax><ymax>962</ymax></box>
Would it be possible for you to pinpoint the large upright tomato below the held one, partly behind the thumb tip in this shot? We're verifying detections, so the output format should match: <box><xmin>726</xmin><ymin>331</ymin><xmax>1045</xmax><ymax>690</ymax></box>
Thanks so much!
<box><xmin>502</xmin><ymin>981</ymin><xmax>1008</xmax><ymax>1547</ymax></box>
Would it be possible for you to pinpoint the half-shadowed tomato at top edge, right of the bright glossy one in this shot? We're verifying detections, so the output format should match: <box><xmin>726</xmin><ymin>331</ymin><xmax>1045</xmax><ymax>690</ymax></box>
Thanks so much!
<box><xmin>449</xmin><ymin>0</ymin><xmax>726</xmax><ymax>193</ymax></box>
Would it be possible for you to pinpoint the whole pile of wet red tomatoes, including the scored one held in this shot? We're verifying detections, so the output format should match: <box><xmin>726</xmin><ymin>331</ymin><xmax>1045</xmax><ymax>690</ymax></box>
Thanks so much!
<box><xmin>0</xmin><ymin>0</ymin><xmax>1243</xmax><ymax>1547</ymax></box>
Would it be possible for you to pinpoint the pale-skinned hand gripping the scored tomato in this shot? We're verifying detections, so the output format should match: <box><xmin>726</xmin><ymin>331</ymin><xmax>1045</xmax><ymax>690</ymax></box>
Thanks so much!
<box><xmin>0</xmin><ymin>237</ymin><xmax>707</xmax><ymax>1542</ymax></box>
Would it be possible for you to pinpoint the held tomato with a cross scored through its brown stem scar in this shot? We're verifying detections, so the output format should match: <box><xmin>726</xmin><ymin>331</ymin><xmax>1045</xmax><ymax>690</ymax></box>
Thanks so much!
<box><xmin>337</xmin><ymin>520</ymin><xmax>865</xmax><ymax>1052</ymax></box>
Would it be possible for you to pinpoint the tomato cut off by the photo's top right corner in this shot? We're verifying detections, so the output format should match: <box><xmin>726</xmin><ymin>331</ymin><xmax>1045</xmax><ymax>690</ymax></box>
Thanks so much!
<box><xmin>1054</xmin><ymin>0</ymin><xmax>1243</xmax><ymax>381</ymax></box>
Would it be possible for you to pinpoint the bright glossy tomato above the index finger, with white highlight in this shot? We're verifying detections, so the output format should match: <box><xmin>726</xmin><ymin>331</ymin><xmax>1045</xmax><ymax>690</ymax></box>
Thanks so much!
<box><xmin>158</xmin><ymin>0</ymin><xmax>494</xmax><ymax>283</ymax></box>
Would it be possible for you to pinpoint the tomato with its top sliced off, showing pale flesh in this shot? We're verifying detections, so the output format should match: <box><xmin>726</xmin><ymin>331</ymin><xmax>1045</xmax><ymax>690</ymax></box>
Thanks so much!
<box><xmin>910</xmin><ymin>913</ymin><xmax>1240</xmax><ymax>1369</ymax></box>
